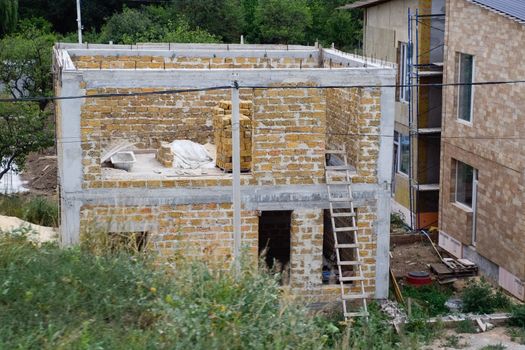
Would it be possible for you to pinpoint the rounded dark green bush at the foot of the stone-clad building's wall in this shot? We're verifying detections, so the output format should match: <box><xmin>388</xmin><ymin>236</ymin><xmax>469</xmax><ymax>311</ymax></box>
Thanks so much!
<box><xmin>461</xmin><ymin>280</ymin><xmax>510</xmax><ymax>314</ymax></box>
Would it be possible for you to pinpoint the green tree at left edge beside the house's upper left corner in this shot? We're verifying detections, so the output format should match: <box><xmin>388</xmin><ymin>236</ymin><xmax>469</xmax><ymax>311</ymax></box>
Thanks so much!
<box><xmin>0</xmin><ymin>21</ymin><xmax>56</xmax><ymax>110</ymax></box>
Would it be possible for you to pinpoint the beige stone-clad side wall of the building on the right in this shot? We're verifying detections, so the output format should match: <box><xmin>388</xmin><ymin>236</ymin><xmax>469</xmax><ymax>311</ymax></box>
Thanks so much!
<box><xmin>439</xmin><ymin>0</ymin><xmax>525</xmax><ymax>280</ymax></box>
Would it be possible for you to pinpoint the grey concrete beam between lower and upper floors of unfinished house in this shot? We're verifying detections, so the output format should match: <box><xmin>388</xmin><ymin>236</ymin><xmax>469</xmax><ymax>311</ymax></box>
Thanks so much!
<box><xmin>62</xmin><ymin>184</ymin><xmax>378</xmax><ymax>210</ymax></box>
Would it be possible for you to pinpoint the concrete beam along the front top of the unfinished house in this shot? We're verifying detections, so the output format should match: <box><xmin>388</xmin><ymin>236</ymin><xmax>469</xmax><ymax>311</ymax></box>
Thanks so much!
<box><xmin>82</xmin><ymin>68</ymin><xmax>394</xmax><ymax>89</ymax></box>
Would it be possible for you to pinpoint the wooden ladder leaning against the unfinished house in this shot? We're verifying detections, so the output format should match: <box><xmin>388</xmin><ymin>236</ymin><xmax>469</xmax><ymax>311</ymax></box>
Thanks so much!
<box><xmin>325</xmin><ymin>149</ymin><xmax>368</xmax><ymax>320</ymax></box>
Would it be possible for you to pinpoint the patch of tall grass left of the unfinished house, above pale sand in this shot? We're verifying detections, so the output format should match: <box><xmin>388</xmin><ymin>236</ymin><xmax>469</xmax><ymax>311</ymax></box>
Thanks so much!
<box><xmin>0</xmin><ymin>195</ymin><xmax>59</xmax><ymax>227</ymax></box>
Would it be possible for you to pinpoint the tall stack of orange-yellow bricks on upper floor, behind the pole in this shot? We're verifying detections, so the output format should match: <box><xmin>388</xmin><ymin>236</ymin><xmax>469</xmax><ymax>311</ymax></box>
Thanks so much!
<box><xmin>213</xmin><ymin>101</ymin><xmax>253</xmax><ymax>171</ymax></box>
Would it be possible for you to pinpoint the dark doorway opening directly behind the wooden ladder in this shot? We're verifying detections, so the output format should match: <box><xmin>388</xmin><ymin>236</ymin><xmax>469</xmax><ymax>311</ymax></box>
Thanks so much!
<box><xmin>322</xmin><ymin>208</ymin><xmax>357</xmax><ymax>284</ymax></box>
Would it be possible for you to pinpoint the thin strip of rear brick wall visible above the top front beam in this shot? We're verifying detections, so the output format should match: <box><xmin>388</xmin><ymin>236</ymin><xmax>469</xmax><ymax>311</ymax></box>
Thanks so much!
<box><xmin>71</xmin><ymin>55</ymin><xmax>318</xmax><ymax>69</ymax></box>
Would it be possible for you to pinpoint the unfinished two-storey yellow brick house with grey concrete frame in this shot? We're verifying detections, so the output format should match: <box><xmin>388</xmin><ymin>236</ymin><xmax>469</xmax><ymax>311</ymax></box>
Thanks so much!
<box><xmin>54</xmin><ymin>44</ymin><xmax>395</xmax><ymax>301</ymax></box>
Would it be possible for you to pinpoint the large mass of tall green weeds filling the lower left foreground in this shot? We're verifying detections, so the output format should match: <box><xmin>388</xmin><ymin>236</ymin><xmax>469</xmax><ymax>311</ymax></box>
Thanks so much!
<box><xmin>0</xmin><ymin>234</ymin><xmax>340</xmax><ymax>349</ymax></box>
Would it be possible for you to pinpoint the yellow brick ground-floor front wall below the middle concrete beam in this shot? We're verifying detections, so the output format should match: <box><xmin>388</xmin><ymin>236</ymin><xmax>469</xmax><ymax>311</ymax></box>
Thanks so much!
<box><xmin>80</xmin><ymin>203</ymin><xmax>376</xmax><ymax>301</ymax></box>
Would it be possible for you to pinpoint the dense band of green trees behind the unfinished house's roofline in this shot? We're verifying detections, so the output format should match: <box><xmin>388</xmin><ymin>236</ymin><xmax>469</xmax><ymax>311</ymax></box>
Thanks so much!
<box><xmin>8</xmin><ymin>0</ymin><xmax>362</xmax><ymax>50</ymax></box>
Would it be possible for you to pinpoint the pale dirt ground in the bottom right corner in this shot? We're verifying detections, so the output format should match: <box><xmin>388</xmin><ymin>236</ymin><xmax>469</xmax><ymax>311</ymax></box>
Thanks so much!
<box><xmin>424</xmin><ymin>327</ymin><xmax>525</xmax><ymax>350</ymax></box>
